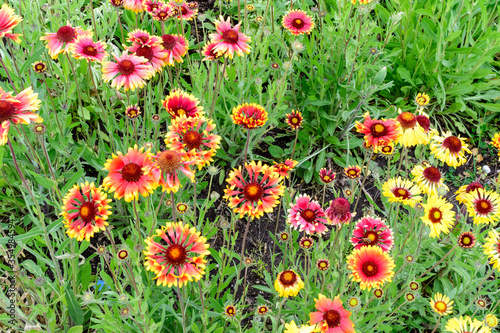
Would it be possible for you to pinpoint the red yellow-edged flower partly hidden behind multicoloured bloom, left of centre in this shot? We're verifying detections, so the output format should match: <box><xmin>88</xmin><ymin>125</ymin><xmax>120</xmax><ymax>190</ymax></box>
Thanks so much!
<box><xmin>161</xmin><ymin>89</ymin><xmax>203</xmax><ymax>119</ymax></box>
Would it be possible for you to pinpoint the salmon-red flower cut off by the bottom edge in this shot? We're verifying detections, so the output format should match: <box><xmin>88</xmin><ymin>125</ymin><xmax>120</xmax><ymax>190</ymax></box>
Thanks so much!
<box><xmin>309</xmin><ymin>294</ymin><xmax>355</xmax><ymax>333</ymax></box>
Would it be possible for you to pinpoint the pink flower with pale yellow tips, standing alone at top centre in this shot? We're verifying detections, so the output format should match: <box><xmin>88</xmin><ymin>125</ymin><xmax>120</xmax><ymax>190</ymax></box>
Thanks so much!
<box><xmin>210</xmin><ymin>15</ymin><xmax>251</xmax><ymax>59</ymax></box>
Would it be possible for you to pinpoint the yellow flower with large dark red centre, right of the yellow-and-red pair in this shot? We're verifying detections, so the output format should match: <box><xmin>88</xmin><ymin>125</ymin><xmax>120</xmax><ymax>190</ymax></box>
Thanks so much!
<box><xmin>430</xmin><ymin>132</ymin><xmax>471</xmax><ymax>168</ymax></box>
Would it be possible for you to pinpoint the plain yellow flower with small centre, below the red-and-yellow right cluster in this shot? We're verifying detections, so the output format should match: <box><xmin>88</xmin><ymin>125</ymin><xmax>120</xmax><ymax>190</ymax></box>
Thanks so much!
<box><xmin>421</xmin><ymin>195</ymin><xmax>455</xmax><ymax>238</ymax></box>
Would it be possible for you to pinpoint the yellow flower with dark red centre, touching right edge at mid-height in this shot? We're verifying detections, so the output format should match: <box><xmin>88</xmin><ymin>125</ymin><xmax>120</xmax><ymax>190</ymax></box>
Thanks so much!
<box><xmin>465</xmin><ymin>189</ymin><xmax>500</xmax><ymax>224</ymax></box>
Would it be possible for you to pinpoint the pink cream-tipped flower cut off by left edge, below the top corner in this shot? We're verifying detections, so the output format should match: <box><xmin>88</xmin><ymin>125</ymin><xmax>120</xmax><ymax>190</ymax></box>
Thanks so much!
<box><xmin>0</xmin><ymin>87</ymin><xmax>43</xmax><ymax>146</ymax></box>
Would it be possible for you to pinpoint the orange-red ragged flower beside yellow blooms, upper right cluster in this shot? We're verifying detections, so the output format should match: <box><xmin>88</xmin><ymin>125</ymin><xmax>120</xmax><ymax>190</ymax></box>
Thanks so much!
<box><xmin>356</xmin><ymin>112</ymin><xmax>402</xmax><ymax>153</ymax></box>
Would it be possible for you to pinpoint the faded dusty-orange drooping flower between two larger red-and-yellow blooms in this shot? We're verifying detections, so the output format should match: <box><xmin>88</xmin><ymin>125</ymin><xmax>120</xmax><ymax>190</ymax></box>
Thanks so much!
<box><xmin>144</xmin><ymin>150</ymin><xmax>194</xmax><ymax>193</ymax></box>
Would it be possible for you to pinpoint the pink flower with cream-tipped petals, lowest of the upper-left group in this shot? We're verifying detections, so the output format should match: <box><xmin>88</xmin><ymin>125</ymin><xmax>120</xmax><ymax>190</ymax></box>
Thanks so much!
<box><xmin>102</xmin><ymin>51</ymin><xmax>153</xmax><ymax>91</ymax></box>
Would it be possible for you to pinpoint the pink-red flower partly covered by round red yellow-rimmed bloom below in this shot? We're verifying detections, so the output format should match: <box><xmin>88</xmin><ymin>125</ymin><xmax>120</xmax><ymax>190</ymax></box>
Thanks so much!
<box><xmin>351</xmin><ymin>216</ymin><xmax>394</xmax><ymax>252</ymax></box>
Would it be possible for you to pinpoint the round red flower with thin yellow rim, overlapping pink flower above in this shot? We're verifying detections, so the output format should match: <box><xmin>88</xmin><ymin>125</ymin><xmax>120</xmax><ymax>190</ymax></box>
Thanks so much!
<box><xmin>347</xmin><ymin>245</ymin><xmax>396</xmax><ymax>290</ymax></box>
